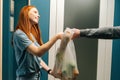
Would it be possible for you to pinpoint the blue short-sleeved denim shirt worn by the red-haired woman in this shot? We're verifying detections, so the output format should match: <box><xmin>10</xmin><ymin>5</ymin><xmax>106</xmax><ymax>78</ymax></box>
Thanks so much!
<box><xmin>13</xmin><ymin>29</ymin><xmax>41</xmax><ymax>76</ymax></box>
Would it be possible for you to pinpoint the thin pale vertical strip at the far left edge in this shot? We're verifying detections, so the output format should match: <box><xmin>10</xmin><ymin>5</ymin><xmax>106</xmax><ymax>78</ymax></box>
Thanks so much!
<box><xmin>0</xmin><ymin>0</ymin><xmax>3</xmax><ymax>80</ymax></box>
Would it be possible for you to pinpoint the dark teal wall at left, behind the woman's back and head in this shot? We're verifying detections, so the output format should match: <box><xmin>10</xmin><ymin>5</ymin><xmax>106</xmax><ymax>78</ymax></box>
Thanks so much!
<box><xmin>2</xmin><ymin>0</ymin><xmax>28</xmax><ymax>80</ymax></box>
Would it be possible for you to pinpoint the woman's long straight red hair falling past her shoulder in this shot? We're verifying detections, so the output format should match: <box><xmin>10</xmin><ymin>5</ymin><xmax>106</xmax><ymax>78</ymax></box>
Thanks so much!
<box><xmin>16</xmin><ymin>5</ymin><xmax>43</xmax><ymax>45</ymax></box>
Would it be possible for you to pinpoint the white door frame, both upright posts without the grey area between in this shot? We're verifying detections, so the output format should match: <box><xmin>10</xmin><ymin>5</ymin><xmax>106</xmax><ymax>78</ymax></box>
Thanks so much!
<box><xmin>48</xmin><ymin>0</ymin><xmax>114</xmax><ymax>80</ymax></box>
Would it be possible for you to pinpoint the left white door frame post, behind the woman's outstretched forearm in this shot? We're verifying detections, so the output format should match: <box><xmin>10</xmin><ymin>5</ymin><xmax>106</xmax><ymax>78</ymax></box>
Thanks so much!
<box><xmin>48</xmin><ymin>0</ymin><xmax>64</xmax><ymax>80</ymax></box>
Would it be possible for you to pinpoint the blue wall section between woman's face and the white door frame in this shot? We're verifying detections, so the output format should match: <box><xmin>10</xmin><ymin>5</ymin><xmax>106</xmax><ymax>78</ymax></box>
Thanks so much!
<box><xmin>30</xmin><ymin>0</ymin><xmax>50</xmax><ymax>80</ymax></box>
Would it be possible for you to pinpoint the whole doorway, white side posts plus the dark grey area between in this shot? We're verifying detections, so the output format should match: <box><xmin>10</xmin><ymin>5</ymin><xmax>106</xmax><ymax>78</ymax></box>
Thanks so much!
<box><xmin>49</xmin><ymin>0</ymin><xmax>114</xmax><ymax>80</ymax></box>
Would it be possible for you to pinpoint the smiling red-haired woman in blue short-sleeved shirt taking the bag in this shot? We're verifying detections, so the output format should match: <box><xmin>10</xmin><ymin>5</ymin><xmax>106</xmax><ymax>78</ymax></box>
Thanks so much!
<box><xmin>13</xmin><ymin>6</ymin><xmax>63</xmax><ymax>80</ymax></box>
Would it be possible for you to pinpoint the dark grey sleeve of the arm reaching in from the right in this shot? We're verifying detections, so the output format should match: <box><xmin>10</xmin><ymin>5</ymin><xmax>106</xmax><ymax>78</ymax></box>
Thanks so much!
<box><xmin>80</xmin><ymin>26</ymin><xmax>120</xmax><ymax>39</ymax></box>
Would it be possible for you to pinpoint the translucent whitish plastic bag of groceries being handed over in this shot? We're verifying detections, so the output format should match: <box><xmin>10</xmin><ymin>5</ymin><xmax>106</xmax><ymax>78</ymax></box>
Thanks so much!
<box><xmin>53</xmin><ymin>29</ymin><xmax>79</xmax><ymax>80</ymax></box>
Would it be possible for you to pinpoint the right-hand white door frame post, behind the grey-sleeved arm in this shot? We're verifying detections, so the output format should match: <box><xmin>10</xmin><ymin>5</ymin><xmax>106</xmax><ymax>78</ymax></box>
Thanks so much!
<box><xmin>97</xmin><ymin>0</ymin><xmax>115</xmax><ymax>80</ymax></box>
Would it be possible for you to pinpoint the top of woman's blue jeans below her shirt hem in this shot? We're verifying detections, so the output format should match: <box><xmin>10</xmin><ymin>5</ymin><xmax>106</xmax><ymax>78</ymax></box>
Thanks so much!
<box><xmin>16</xmin><ymin>73</ymin><xmax>40</xmax><ymax>80</ymax></box>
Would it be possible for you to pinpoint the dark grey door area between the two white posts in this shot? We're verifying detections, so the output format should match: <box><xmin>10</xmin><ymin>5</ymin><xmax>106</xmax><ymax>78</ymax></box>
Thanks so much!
<box><xmin>64</xmin><ymin>0</ymin><xmax>100</xmax><ymax>80</ymax></box>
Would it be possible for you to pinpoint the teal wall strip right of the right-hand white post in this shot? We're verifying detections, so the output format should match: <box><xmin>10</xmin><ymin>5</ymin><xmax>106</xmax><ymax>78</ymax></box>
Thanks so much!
<box><xmin>111</xmin><ymin>0</ymin><xmax>120</xmax><ymax>80</ymax></box>
